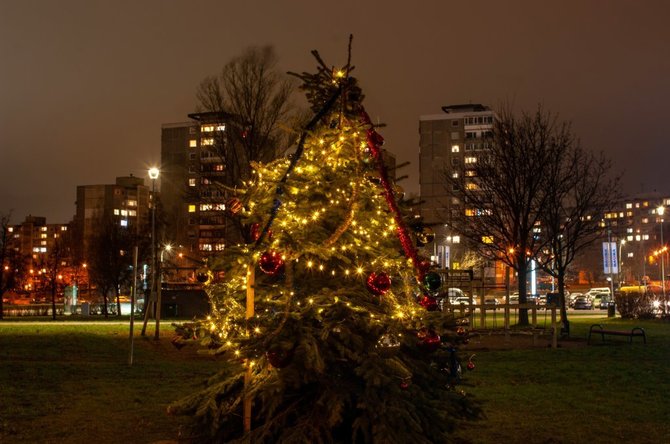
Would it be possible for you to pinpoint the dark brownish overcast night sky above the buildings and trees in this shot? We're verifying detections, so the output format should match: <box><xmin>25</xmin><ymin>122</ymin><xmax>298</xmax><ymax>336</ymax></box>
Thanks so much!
<box><xmin>0</xmin><ymin>0</ymin><xmax>670</xmax><ymax>223</ymax></box>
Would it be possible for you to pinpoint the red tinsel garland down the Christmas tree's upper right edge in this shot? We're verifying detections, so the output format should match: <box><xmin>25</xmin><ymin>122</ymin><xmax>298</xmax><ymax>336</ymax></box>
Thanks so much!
<box><xmin>361</xmin><ymin>111</ymin><xmax>427</xmax><ymax>282</ymax></box>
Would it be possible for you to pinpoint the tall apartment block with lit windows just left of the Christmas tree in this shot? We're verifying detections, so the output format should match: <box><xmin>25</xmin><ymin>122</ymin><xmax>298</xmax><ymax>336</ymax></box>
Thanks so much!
<box><xmin>161</xmin><ymin>113</ymin><xmax>226</xmax><ymax>258</ymax></box>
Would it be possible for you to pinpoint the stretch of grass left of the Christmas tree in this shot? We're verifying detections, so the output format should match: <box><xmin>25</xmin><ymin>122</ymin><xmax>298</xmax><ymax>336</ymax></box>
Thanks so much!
<box><xmin>0</xmin><ymin>322</ymin><xmax>221</xmax><ymax>443</ymax></box>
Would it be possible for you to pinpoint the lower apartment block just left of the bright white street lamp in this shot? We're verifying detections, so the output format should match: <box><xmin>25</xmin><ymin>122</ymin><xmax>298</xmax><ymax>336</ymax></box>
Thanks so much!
<box><xmin>73</xmin><ymin>175</ymin><xmax>153</xmax><ymax>260</ymax></box>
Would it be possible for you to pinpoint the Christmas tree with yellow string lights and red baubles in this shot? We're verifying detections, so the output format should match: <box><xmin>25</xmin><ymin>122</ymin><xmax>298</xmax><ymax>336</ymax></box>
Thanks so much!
<box><xmin>170</xmin><ymin>44</ymin><xmax>479</xmax><ymax>443</ymax></box>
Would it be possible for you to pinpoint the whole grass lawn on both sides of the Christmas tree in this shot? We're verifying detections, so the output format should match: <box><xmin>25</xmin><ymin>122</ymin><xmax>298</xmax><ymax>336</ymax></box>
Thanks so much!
<box><xmin>0</xmin><ymin>317</ymin><xmax>670</xmax><ymax>444</ymax></box>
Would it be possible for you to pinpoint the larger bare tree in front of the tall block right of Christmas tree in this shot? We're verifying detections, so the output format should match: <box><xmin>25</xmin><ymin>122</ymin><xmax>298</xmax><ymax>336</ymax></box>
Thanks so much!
<box><xmin>446</xmin><ymin>107</ymin><xmax>572</xmax><ymax>325</ymax></box>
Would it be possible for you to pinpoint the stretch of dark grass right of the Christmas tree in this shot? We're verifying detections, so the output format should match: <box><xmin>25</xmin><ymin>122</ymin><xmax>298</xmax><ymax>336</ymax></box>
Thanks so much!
<box><xmin>459</xmin><ymin>317</ymin><xmax>670</xmax><ymax>443</ymax></box>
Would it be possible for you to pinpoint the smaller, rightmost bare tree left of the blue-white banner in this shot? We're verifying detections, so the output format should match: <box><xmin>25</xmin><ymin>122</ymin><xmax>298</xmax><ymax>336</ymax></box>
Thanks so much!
<box><xmin>536</xmin><ymin>147</ymin><xmax>620</xmax><ymax>334</ymax></box>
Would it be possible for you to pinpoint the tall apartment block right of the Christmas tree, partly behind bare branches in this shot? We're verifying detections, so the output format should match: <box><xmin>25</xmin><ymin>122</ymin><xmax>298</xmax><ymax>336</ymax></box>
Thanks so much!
<box><xmin>419</xmin><ymin>104</ymin><xmax>494</xmax><ymax>269</ymax></box>
